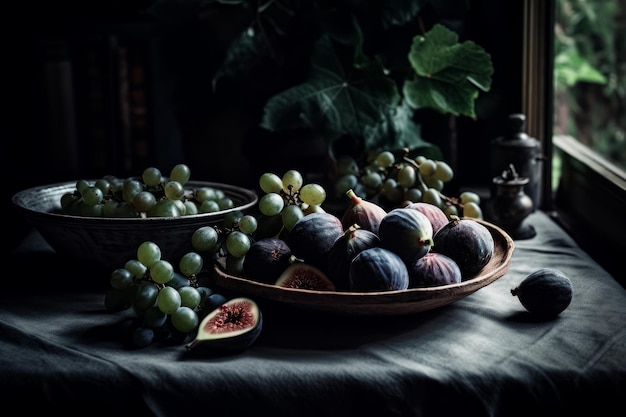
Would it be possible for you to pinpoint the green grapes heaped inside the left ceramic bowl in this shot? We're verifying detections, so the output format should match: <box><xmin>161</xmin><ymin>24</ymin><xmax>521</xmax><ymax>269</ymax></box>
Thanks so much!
<box><xmin>61</xmin><ymin>164</ymin><xmax>234</xmax><ymax>217</ymax></box>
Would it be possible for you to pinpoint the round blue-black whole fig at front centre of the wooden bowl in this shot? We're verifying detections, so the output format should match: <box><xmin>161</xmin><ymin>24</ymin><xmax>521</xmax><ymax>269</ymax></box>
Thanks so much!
<box><xmin>348</xmin><ymin>247</ymin><xmax>409</xmax><ymax>292</ymax></box>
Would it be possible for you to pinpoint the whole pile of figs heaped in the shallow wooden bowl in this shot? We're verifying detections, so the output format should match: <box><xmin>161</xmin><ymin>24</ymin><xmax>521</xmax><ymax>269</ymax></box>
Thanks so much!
<box><xmin>242</xmin><ymin>192</ymin><xmax>494</xmax><ymax>292</ymax></box>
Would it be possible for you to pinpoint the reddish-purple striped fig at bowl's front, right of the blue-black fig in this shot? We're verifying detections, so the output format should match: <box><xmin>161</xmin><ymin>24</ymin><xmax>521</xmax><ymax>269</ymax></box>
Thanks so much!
<box><xmin>407</xmin><ymin>252</ymin><xmax>461</xmax><ymax>288</ymax></box>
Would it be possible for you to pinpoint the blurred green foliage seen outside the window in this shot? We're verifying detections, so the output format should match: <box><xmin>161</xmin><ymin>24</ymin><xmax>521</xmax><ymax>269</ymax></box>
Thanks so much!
<box><xmin>554</xmin><ymin>0</ymin><xmax>626</xmax><ymax>170</ymax></box>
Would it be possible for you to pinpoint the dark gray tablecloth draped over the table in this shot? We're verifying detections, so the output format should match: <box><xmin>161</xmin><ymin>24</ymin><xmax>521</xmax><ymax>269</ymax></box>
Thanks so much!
<box><xmin>0</xmin><ymin>212</ymin><xmax>626</xmax><ymax>417</ymax></box>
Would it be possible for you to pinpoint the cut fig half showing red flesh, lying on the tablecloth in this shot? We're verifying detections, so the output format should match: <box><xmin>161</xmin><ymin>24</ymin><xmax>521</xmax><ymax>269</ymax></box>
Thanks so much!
<box><xmin>186</xmin><ymin>297</ymin><xmax>263</xmax><ymax>350</ymax></box>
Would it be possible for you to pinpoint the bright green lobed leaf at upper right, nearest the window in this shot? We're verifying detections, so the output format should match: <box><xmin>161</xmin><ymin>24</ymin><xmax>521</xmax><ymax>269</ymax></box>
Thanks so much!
<box><xmin>403</xmin><ymin>24</ymin><xmax>493</xmax><ymax>118</ymax></box>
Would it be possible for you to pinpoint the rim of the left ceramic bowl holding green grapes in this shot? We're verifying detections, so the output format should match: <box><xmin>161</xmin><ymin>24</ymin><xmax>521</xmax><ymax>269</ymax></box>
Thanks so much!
<box><xmin>11</xmin><ymin>179</ymin><xmax>259</xmax><ymax>224</ymax></box>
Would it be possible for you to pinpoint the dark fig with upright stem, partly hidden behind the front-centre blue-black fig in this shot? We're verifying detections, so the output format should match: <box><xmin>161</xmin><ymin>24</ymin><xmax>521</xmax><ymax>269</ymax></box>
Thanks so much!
<box><xmin>328</xmin><ymin>224</ymin><xmax>380</xmax><ymax>291</ymax></box>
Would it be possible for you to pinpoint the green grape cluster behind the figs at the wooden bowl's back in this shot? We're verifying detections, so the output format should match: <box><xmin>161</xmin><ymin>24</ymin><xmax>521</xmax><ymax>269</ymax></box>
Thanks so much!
<box><xmin>334</xmin><ymin>149</ymin><xmax>483</xmax><ymax>219</ymax></box>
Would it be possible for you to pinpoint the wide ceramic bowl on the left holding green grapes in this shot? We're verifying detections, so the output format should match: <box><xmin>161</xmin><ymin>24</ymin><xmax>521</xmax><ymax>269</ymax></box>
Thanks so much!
<box><xmin>12</xmin><ymin>181</ymin><xmax>258</xmax><ymax>270</ymax></box>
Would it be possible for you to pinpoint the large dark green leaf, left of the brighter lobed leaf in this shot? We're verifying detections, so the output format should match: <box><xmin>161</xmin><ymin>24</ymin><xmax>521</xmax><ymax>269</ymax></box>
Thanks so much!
<box><xmin>261</xmin><ymin>37</ymin><xmax>400</xmax><ymax>136</ymax></box>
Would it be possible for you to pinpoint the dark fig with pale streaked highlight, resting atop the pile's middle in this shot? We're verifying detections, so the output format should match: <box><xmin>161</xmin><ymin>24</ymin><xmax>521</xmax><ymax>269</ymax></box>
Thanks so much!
<box><xmin>378</xmin><ymin>207</ymin><xmax>433</xmax><ymax>262</ymax></box>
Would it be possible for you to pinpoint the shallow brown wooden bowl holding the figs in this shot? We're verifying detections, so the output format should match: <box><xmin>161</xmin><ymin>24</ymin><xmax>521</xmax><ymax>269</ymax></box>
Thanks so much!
<box><xmin>214</xmin><ymin>220</ymin><xmax>515</xmax><ymax>316</ymax></box>
